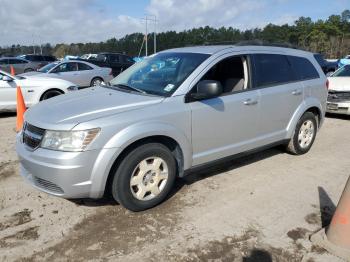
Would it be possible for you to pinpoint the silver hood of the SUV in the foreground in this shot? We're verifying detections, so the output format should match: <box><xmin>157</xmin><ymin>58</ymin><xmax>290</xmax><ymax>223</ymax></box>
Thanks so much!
<box><xmin>25</xmin><ymin>87</ymin><xmax>164</xmax><ymax>130</ymax></box>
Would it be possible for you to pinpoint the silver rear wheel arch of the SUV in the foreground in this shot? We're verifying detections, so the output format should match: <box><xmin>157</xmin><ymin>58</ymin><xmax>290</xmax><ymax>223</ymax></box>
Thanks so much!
<box><xmin>286</xmin><ymin>97</ymin><xmax>324</xmax><ymax>139</ymax></box>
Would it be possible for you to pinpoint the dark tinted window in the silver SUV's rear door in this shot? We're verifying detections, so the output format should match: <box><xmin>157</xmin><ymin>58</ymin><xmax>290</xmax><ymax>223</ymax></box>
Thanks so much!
<box><xmin>254</xmin><ymin>54</ymin><xmax>296</xmax><ymax>87</ymax></box>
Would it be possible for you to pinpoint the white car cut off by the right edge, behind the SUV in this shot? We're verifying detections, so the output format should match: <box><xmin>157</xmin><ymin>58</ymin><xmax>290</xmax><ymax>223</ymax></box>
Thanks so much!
<box><xmin>327</xmin><ymin>65</ymin><xmax>350</xmax><ymax>115</ymax></box>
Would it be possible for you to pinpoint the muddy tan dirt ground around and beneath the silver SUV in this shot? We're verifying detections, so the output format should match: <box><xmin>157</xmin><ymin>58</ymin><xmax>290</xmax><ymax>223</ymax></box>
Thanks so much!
<box><xmin>0</xmin><ymin>114</ymin><xmax>350</xmax><ymax>262</ymax></box>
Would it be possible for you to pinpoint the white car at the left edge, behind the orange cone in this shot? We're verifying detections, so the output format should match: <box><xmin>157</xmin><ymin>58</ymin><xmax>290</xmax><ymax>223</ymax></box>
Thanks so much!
<box><xmin>0</xmin><ymin>70</ymin><xmax>78</xmax><ymax>112</ymax></box>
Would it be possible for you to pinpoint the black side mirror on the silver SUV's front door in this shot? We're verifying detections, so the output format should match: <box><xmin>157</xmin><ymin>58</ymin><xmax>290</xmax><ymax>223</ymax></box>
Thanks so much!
<box><xmin>187</xmin><ymin>80</ymin><xmax>223</xmax><ymax>100</ymax></box>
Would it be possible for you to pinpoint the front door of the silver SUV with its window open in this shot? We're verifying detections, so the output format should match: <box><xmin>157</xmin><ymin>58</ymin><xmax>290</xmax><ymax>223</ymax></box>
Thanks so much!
<box><xmin>189</xmin><ymin>56</ymin><xmax>260</xmax><ymax>166</ymax></box>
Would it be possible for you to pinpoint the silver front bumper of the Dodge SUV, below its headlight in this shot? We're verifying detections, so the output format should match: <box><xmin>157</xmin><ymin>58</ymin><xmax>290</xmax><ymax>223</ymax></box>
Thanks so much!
<box><xmin>16</xmin><ymin>134</ymin><xmax>116</xmax><ymax>198</ymax></box>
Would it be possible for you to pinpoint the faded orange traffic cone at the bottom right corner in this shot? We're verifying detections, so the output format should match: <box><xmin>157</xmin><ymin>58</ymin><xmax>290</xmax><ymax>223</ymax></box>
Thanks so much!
<box><xmin>311</xmin><ymin>177</ymin><xmax>350</xmax><ymax>261</ymax></box>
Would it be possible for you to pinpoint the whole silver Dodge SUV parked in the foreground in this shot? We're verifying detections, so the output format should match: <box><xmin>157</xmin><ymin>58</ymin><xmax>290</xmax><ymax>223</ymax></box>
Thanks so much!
<box><xmin>16</xmin><ymin>46</ymin><xmax>327</xmax><ymax>211</ymax></box>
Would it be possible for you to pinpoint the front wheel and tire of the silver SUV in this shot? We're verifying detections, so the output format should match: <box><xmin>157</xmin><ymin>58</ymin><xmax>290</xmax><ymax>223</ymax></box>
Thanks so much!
<box><xmin>111</xmin><ymin>143</ymin><xmax>177</xmax><ymax>212</ymax></box>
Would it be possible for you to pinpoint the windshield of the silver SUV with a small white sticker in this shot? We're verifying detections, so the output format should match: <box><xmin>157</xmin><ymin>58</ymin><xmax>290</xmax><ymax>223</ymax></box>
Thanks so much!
<box><xmin>110</xmin><ymin>53</ymin><xmax>209</xmax><ymax>96</ymax></box>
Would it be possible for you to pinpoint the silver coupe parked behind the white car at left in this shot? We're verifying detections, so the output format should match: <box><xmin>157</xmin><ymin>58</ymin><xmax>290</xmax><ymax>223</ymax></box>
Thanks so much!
<box><xmin>21</xmin><ymin>60</ymin><xmax>113</xmax><ymax>87</ymax></box>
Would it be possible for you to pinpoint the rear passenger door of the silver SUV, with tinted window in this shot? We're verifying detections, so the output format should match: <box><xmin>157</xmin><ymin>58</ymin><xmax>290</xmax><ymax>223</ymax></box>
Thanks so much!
<box><xmin>253</xmin><ymin>54</ymin><xmax>304</xmax><ymax>144</ymax></box>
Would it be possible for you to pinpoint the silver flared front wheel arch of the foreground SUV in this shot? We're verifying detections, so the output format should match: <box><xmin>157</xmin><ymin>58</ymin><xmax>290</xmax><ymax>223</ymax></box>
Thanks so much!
<box><xmin>87</xmin><ymin>123</ymin><xmax>192</xmax><ymax>198</ymax></box>
